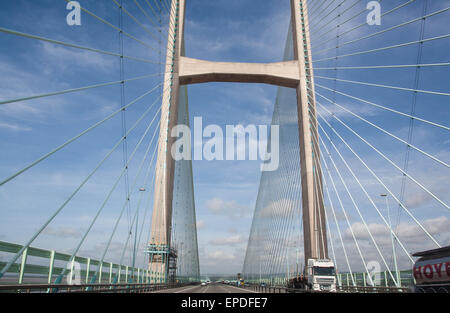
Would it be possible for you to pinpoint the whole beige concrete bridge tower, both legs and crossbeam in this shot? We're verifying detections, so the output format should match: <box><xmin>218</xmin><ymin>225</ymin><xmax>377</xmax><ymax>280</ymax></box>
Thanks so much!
<box><xmin>149</xmin><ymin>0</ymin><xmax>328</xmax><ymax>282</ymax></box>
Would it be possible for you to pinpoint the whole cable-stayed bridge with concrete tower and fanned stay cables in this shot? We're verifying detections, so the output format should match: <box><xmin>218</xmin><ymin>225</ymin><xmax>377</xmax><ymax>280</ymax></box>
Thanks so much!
<box><xmin>0</xmin><ymin>0</ymin><xmax>450</xmax><ymax>292</ymax></box>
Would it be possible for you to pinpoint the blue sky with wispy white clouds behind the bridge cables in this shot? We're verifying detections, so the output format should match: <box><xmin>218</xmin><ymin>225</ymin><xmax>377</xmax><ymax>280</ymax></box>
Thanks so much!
<box><xmin>0</xmin><ymin>0</ymin><xmax>450</xmax><ymax>274</ymax></box>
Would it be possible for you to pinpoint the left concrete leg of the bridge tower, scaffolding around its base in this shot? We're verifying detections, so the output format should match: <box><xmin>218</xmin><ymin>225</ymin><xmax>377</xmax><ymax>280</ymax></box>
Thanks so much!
<box><xmin>149</xmin><ymin>0</ymin><xmax>185</xmax><ymax>283</ymax></box>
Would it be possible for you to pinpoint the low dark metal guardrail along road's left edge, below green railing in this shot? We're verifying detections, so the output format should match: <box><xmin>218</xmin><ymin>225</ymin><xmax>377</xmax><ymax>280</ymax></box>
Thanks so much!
<box><xmin>0</xmin><ymin>284</ymin><xmax>188</xmax><ymax>293</ymax></box>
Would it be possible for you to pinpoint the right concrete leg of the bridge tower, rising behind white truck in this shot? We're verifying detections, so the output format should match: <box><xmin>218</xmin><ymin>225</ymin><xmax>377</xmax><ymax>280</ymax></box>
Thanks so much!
<box><xmin>291</xmin><ymin>0</ymin><xmax>328</xmax><ymax>265</ymax></box>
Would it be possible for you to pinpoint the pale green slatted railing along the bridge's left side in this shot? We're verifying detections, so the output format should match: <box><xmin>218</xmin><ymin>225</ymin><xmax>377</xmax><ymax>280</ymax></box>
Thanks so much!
<box><xmin>0</xmin><ymin>241</ymin><xmax>153</xmax><ymax>285</ymax></box>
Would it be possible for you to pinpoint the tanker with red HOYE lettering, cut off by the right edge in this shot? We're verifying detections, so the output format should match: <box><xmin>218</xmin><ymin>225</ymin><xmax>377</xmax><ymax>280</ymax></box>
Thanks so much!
<box><xmin>413</xmin><ymin>246</ymin><xmax>450</xmax><ymax>293</ymax></box>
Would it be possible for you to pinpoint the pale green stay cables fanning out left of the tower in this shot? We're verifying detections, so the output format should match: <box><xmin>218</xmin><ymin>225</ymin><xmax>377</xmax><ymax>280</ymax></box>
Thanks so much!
<box><xmin>0</xmin><ymin>0</ymin><xmax>173</xmax><ymax>283</ymax></box>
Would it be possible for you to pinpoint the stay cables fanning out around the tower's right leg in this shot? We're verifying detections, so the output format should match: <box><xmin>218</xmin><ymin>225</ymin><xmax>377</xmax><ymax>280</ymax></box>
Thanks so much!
<box><xmin>243</xmin><ymin>0</ymin><xmax>450</xmax><ymax>287</ymax></box>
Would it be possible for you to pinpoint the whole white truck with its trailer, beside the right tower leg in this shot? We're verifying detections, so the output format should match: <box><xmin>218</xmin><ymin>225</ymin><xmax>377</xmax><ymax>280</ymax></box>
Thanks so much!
<box><xmin>288</xmin><ymin>259</ymin><xmax>337</xmax><ymax>292</ymax></box>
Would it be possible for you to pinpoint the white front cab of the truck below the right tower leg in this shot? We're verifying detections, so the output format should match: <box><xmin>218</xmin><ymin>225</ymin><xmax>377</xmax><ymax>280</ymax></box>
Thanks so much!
<box><xmin>306</xmin><ymin>259</ymin><xmax>336</xmax><ymax>292</ymax></box>
